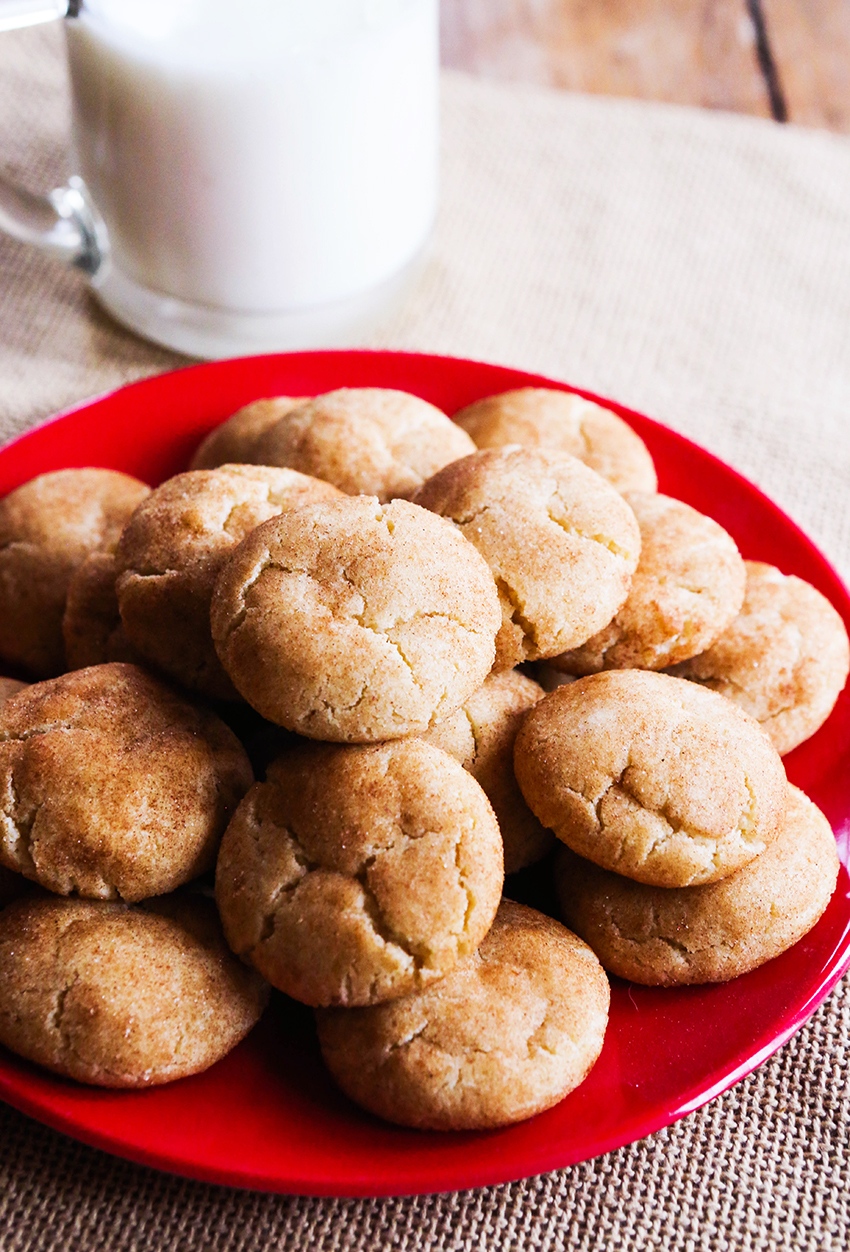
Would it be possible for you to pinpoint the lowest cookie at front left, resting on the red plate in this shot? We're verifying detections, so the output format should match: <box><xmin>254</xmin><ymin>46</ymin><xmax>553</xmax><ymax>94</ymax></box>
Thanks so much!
<box><xmin>0</xmin><ymin>896</ymin><xmax>268</xmax><ymax>1087</ymax></box>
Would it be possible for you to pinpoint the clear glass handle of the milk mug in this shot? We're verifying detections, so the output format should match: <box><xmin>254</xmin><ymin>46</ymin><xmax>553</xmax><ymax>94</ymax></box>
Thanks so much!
<box><xmin>0</xmin><ymin>0</ymin><xmax>103</xmax><ymax>274</ymax></box>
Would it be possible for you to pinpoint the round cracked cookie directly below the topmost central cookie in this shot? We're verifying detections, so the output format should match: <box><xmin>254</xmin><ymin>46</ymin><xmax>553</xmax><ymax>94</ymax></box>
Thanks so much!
<box><xmin>215</xmin><ymin>739</ymin><xmax>504</xmax><ymax>1005</ymax></box>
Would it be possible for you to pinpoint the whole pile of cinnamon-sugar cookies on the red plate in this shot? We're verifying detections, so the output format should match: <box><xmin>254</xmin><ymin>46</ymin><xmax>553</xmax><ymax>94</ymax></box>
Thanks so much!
<box><xmin>0</xmin><ymin>388</ymin><xmax>849</xmax><ymax>1129</ymax></box>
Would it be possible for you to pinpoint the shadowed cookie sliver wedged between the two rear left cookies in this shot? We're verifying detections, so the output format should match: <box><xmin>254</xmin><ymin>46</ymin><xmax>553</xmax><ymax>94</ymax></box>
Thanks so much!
<box><xmin>63</xmin><ymin>552</ymin><xmax>141</xmax><ymax>670</ymax></box>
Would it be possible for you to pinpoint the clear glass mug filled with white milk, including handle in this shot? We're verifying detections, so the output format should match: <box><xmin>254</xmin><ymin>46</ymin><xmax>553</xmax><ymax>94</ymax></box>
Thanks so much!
<box><xmin>0</xmin><ymin>0</ymin><xmax>438</xmax><ymax>357</ymax></box>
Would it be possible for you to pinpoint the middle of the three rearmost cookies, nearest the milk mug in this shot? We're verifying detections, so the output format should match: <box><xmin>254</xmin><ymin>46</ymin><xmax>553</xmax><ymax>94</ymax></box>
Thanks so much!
<box><xmin>254</xmin><ymin>387</ymin><xmax>476</xmax><ymax>501</ymax></box>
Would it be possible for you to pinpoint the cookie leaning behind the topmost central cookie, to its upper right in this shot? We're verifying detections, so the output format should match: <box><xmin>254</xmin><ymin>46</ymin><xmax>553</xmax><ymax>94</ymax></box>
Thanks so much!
<box><xmin>414</xmin><ymin>448</ymin><xmax>641</xmax><ymax>670</ymax></box>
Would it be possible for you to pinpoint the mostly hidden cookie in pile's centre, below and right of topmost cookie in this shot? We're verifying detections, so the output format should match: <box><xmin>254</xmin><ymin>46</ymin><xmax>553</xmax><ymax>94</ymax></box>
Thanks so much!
<box><xmin>422</xmin><ymin>670</ymin><xmax>556</xmax><ymax>874</ymax></box>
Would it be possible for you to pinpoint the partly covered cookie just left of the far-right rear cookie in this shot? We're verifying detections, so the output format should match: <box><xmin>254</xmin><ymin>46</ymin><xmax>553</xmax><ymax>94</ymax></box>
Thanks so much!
<box><xmin>550</xmin><ymin>492</ymin><xmax>746</xmax><ymax>674</ymax></box>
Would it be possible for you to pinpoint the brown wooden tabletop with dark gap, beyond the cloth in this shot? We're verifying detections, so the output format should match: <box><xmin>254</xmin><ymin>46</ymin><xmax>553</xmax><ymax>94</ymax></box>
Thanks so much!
<box><xmin>442</xmin><ymin>0</ymin><xmax>850</xmax><ymax>133</ymax></box>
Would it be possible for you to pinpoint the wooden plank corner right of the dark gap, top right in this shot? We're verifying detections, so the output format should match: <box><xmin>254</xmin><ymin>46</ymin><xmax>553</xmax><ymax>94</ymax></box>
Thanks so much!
<box><xmin>760</xmin><ymin>0</ymin><xmax>850</xmax><ymax>134</ymax></box>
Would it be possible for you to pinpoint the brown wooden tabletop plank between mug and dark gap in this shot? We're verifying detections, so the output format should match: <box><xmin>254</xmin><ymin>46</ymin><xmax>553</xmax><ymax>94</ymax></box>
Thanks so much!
<box><xmin>442</xmin><ymin>0</ymin><xmax>776</xmax><ymax>116</ymax></box>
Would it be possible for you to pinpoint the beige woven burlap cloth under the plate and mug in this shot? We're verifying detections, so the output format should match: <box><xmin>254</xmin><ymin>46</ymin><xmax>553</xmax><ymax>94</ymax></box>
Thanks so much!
<box><xmin>0</xmin><ymin>19</ymin><xmax>850</xmax><ymax>1252</ymax></box>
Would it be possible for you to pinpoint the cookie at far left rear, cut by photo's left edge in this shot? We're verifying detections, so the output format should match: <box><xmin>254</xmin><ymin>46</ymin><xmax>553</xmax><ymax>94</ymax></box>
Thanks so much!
<box><xmin>0</xmin><ymin>470</ymin><xmax>150</xmax><ymax>679</ymax></box>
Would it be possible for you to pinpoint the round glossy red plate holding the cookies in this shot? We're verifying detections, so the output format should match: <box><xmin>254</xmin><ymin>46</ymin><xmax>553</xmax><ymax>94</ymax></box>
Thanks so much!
<box><xmin>0</xmin><ymin>352</ymin><xmax>850</xmax><ymax>1196</ymax></box>
